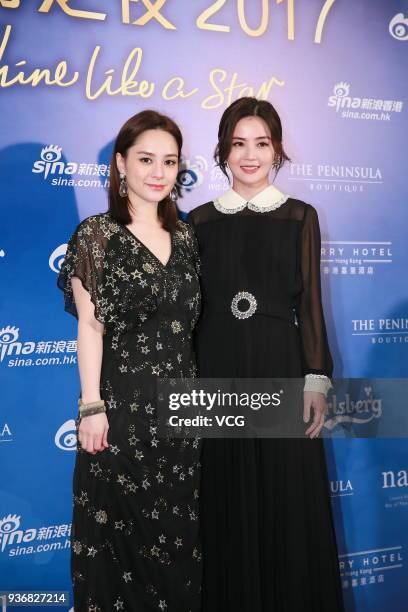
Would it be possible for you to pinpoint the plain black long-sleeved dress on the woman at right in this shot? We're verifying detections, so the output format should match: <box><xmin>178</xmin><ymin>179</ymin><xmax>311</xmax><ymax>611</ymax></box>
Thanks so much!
<box><xmin>188</xmin><ymin>194</ymin><xmax>343</xmax><ymax>612</ymax></box>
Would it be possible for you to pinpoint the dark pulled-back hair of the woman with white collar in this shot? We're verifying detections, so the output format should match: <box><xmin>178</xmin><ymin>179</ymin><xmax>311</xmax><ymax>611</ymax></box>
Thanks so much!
<box><xmin>214</xmin><ymin>96</ymin><xmax>290</xmax><ymax>180</ymax></box>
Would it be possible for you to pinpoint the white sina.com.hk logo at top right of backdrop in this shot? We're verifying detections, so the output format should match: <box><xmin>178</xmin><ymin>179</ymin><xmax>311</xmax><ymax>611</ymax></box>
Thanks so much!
<box><xmin>327</xmin><ymin>81</ymin><xmax>403</xmax><ymax>121</ymax></box>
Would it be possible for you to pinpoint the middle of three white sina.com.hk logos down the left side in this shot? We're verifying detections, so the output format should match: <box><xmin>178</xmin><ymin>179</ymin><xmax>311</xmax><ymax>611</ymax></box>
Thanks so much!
<box><xmin>0</xmin><ymin>325</ymin><xmax>77</xmax><ymax>368</ymax></box>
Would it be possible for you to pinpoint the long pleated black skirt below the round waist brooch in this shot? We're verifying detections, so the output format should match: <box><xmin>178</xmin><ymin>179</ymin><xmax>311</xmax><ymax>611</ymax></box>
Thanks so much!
<box><xmin>196</xmin><ymin>315</ymin><xmax>343</xmax><ymax>612</ymax></box>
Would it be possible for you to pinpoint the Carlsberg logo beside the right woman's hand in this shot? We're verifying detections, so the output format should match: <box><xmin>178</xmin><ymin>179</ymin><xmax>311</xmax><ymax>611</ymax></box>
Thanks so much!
<box><xmin>324</xmin><ymin>387</ymin><xmax>383</xmax><ymax>431</ymax></box>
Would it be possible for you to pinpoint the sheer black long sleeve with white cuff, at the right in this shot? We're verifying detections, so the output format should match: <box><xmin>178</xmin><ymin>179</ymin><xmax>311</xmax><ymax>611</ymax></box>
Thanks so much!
<box><xmin>297</xmin><ymin>205</ymin><xmax>333</xmax><ymax>395</ymax></box>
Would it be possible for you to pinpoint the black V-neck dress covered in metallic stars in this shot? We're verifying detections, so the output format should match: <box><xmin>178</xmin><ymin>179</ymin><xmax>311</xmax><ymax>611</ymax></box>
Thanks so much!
<box><xmin>58</xmin><ymin>213</ymin><xmax>201</xmax><ymax>612</ymax></box>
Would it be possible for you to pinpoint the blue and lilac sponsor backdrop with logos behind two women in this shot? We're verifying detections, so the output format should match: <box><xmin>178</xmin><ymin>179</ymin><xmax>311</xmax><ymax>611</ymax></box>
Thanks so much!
<box><xmin>0</xmin><ymin>0</ymin><xmax>408</xmax><ymax>612</ymax></box>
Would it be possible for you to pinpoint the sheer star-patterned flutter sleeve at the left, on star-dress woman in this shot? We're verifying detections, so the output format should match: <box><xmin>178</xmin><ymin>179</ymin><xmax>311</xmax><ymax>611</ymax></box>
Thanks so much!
<box><xmin>57</xmin><ymin>216</ymin><xmax>109</xmax><ymax>324</ymax></box>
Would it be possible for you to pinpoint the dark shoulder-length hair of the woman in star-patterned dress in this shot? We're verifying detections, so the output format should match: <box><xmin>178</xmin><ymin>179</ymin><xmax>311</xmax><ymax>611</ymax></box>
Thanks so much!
<box><xmin>108</xmin><ymin>110</ymin><xmax>183</xmax><ymax>232</ymax></box>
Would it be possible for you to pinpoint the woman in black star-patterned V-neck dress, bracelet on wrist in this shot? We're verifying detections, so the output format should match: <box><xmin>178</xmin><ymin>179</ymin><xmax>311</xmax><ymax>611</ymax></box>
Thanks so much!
<box><xmin>58</xmin><ymin>111</ymin><xmax>201</xmax><ymax>612</ymax></box>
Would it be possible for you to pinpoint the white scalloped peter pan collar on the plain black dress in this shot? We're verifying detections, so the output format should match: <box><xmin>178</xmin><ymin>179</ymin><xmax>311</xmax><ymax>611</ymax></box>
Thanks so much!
<box><xmin>214</xmin><ymin>185</ymin><xmax>289</xmax><ymax>215</ymax></box>
